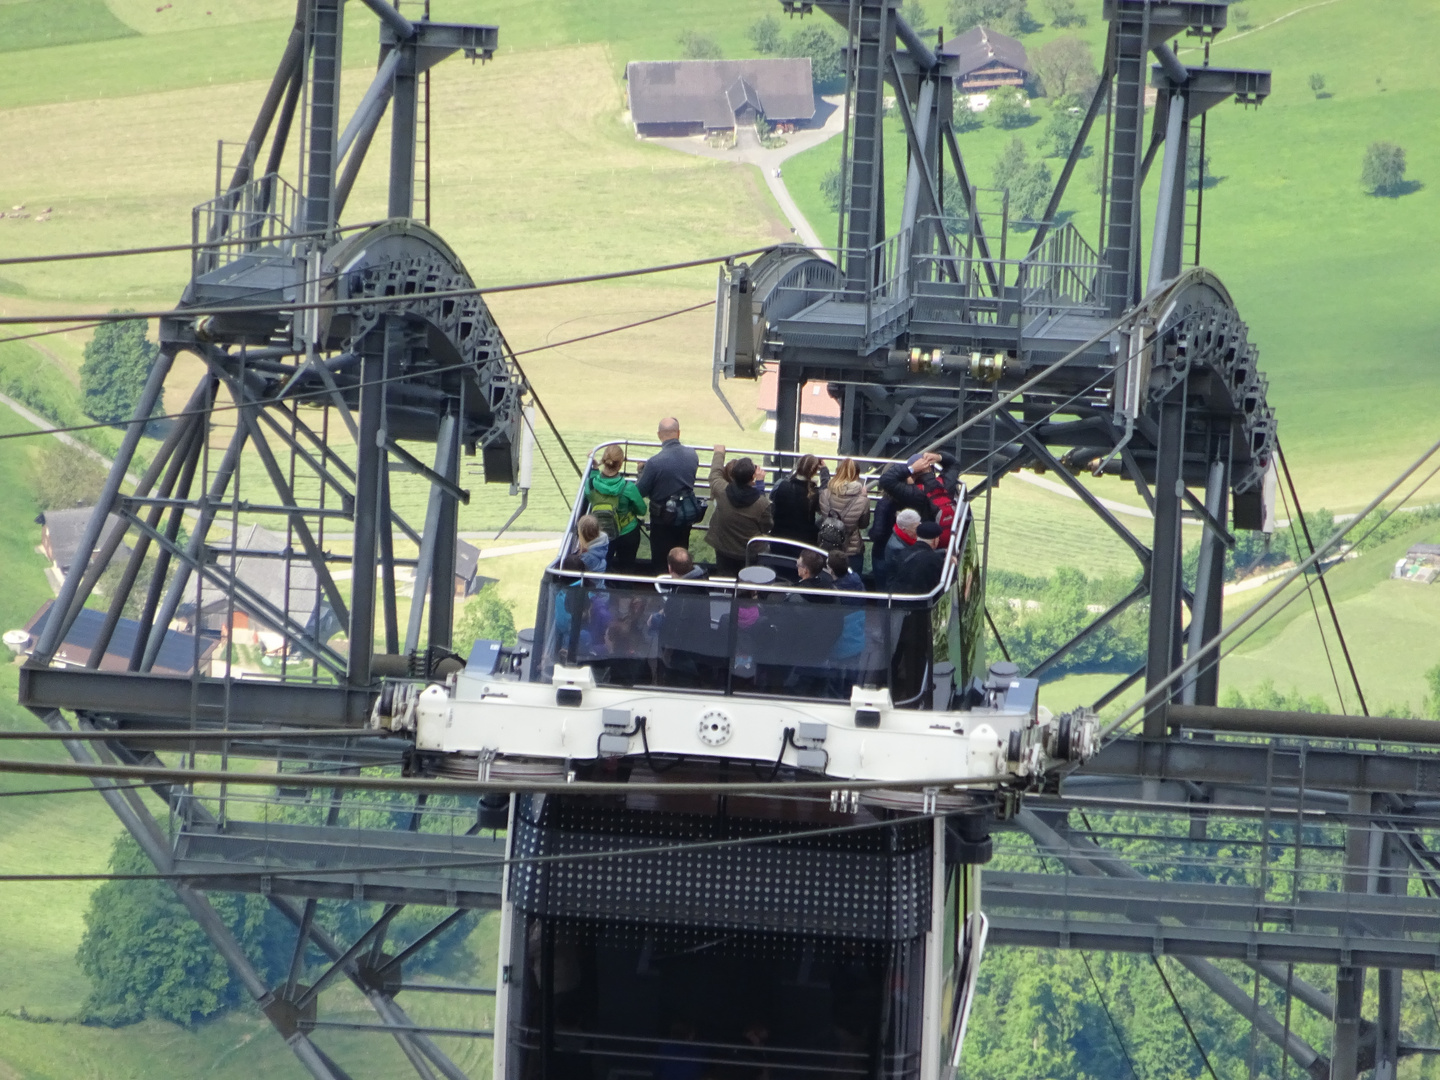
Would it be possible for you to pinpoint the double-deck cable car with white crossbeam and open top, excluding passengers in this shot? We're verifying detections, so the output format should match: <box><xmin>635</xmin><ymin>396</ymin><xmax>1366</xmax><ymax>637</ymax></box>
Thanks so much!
<box><xmin>374</xmin><ymin>444</ymin><xmax>1094</xmax><ymax>1080</ymax></box>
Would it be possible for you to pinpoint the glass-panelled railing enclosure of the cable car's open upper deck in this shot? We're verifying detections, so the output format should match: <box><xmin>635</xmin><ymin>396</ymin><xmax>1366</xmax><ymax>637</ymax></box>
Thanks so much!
<box><xmin>530</xmin><ymin>451</ymin><xmax>984</xmax><ymax>710</ymax></box>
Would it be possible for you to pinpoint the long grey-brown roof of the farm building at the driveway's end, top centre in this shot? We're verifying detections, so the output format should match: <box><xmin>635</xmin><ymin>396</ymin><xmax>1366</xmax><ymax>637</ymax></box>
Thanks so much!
<box><xmin>625</xmin><ymin>56</ymin><xmax>815</xmax><ymax>128</ymax></box>
